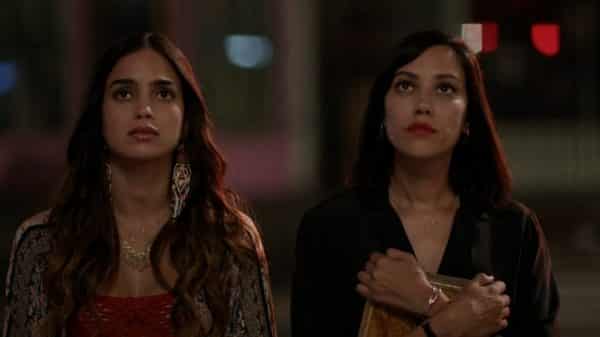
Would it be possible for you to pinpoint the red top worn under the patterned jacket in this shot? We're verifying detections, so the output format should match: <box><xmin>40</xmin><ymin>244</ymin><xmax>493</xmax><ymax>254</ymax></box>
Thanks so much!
<box><xmin>69</xmin><ymin>293</ymin><xmax>174</xmax><ymax>337</ymax></box>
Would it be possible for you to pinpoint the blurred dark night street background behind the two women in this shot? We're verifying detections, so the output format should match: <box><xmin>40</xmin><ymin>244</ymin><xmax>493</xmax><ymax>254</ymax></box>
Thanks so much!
<box><xmin>0</xmin><ymin>0</ymin><xmax>600</xmax><ymax>337</ymax></box>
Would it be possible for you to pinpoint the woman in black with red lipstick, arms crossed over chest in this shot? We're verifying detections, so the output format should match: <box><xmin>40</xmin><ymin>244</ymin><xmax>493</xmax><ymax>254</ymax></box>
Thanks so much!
<box><xmin>292</xmin><ymin>31</ymin><xmax>558</xmax><ymax>337</ymax></box>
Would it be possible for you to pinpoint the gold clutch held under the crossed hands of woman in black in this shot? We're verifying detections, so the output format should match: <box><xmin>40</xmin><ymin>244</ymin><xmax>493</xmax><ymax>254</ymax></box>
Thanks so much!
<box><xmin>358</xmin><ymin>273</ymin><xmax>469</xmax><ymax>337</ymax></box>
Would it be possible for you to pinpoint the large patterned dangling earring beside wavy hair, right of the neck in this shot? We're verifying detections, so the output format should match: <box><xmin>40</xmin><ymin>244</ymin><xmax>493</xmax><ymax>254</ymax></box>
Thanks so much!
<box><xmin>171</xmin><ymin>144</ymin><xmax>192</xmax><ymax>220</ymax></box>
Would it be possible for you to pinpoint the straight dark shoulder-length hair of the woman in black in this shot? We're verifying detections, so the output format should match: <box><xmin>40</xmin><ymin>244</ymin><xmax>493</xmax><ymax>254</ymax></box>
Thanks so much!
<box><xmin>350</xmin><ymin>31</ymin><xmax>511</xmax><ymax>207</ymax></box>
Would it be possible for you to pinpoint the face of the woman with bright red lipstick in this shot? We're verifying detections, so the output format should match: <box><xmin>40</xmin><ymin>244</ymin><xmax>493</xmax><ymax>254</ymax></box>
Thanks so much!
<box><xmin>385</xmin><ymin>45</ymin><xmax>467</xmax><ymax>159</ymax></box>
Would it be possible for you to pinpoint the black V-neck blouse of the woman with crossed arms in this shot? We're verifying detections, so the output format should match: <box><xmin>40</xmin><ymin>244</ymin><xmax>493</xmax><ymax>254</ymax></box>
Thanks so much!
<box><xmin>291</xmin><ymin>190</ymin><xmax>559</xmax><ymax>337</ymax></box>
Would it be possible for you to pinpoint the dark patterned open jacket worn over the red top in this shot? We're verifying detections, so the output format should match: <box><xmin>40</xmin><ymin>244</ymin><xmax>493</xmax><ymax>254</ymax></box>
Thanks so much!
<box><xmin>2</xmin><ymin>212</ymin><xmax>277</xmax><ymax>337</ymax></box>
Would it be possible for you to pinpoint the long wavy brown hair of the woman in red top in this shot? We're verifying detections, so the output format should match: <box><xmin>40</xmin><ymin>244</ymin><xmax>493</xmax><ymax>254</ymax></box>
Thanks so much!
<box><xmin>42</xmin><ymin>33</ymin><xmax>256</xmax><ymax>337</ymax></box>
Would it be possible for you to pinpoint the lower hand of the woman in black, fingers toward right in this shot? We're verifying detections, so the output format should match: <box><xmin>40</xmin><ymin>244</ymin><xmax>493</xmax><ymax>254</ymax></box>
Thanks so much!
<box><xmin>430</xmin><ymin>274</ymin><xmax>510</xmax><ymax>337</ymax></box>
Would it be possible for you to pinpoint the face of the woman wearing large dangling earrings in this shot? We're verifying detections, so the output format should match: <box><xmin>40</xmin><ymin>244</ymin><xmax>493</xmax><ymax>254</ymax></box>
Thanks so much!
<box><xmin>102</xmin><ymin>48</ymin><xmax>184</xmax><ymax>160</ymax></box>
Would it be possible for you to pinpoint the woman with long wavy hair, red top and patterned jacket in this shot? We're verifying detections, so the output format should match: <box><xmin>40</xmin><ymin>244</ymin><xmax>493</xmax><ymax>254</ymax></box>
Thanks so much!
<box><xmin>3</xmin><ymin>33</ymin><xmax>276</xmax><ymax>337</ymax></box>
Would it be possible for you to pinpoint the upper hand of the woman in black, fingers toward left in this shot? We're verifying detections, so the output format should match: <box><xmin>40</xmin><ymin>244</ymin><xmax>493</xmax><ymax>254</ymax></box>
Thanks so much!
<box><xmin>356</xmin><ymin>248</ymin><xmax>433</xmax><ymax>314</ymax></box>
